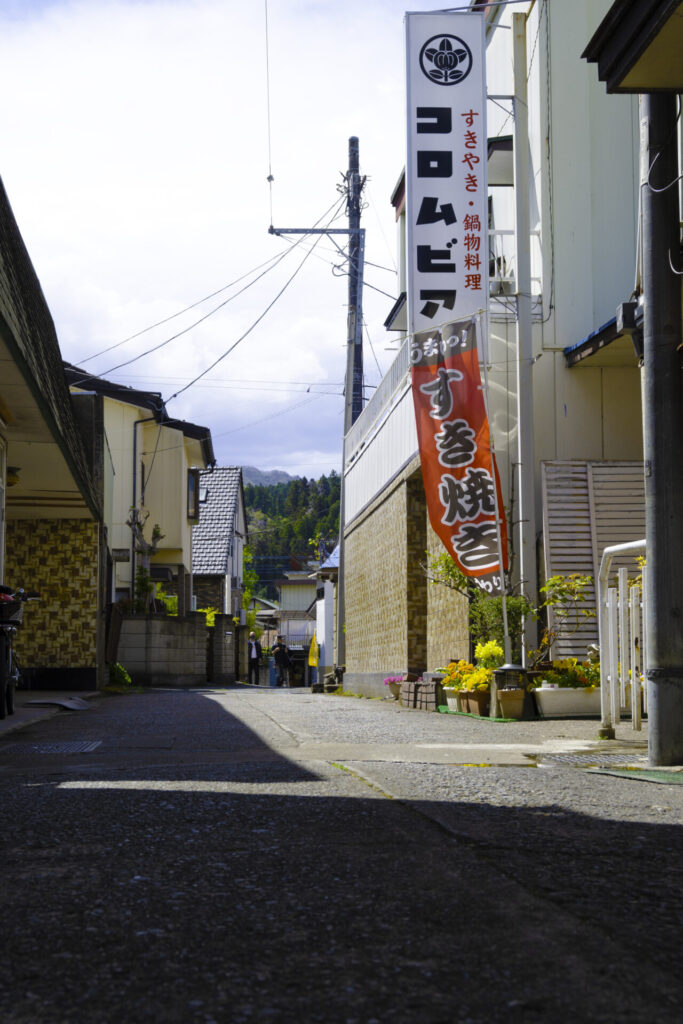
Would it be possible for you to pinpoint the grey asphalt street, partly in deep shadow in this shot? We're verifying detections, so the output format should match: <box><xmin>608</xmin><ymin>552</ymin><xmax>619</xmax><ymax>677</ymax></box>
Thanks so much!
<box><xmin>0</xmin><ymin>687</ymin><xmax>683</xmax><ymax>1024</ymax></box>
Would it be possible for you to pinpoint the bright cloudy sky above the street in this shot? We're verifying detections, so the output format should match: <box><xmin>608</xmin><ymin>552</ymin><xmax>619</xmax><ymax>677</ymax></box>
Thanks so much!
<box><xmin>0</xmin><ymin>0</ymin><xmax>458</xmax><ymax>477</ymax></box>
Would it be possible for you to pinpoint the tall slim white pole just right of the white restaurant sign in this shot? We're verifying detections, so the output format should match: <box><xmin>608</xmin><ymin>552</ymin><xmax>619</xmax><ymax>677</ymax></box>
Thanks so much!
<box><xmin>512</xmin><ymin>14</ymin><xmax>540</xmax><ymax>666</ymax></box>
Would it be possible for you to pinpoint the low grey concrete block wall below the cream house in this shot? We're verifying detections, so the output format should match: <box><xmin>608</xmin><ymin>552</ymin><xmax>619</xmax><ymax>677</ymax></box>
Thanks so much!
<box><xmin>118</xmin><ymin>612</ymin><xmax>207</xmax><ymax>686</ymax></box>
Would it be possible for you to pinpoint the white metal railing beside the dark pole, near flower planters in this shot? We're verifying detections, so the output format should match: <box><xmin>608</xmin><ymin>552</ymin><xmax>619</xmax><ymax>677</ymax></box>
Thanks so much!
<box><xmin>598</xmin><ymin>541</ymin><xmax>647</xmax><ymax>732</ymax></box>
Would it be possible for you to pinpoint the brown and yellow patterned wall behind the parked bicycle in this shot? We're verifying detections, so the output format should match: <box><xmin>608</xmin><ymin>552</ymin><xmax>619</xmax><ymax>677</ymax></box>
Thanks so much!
<box><xmin>5</xmin><ymin>519</ymin><xmax>102</xmax><ymax>689</ymax></box>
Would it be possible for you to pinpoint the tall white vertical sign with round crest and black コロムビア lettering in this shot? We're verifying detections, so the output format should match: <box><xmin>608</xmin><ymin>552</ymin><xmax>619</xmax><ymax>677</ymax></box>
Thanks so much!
<box><xmin>405</xmin><ymin>12</ymin><xmax>488</xmax><ymax>333</ymax></box>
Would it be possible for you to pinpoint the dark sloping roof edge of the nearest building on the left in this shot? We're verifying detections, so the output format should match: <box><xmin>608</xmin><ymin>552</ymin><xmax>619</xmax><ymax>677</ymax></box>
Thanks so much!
<box><xmin>0</xmin><ymin>180</ymin><xmax>101</xmax><ymax>516</ymax></box>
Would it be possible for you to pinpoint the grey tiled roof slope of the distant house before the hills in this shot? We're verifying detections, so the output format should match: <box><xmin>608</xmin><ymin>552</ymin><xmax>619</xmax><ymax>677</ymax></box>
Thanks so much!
<box><xmin>193</xmin><ymin>466</ymin><xmax>242</xmax><ymax>575</ymax></box>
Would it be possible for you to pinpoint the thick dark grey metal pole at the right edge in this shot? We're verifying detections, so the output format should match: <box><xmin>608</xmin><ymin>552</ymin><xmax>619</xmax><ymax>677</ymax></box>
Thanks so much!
<box><xmin>640</xmin><ymin>93</ymin><xmax>683</xmax><ymax>765</ymax></box>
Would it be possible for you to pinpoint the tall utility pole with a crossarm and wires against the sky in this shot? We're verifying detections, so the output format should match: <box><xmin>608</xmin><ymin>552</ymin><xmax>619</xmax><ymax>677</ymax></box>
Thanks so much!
<box><xmin>268</xmin><ymin>135</ymin><xmax>366</xmax><ymax>666</ymax></box>
